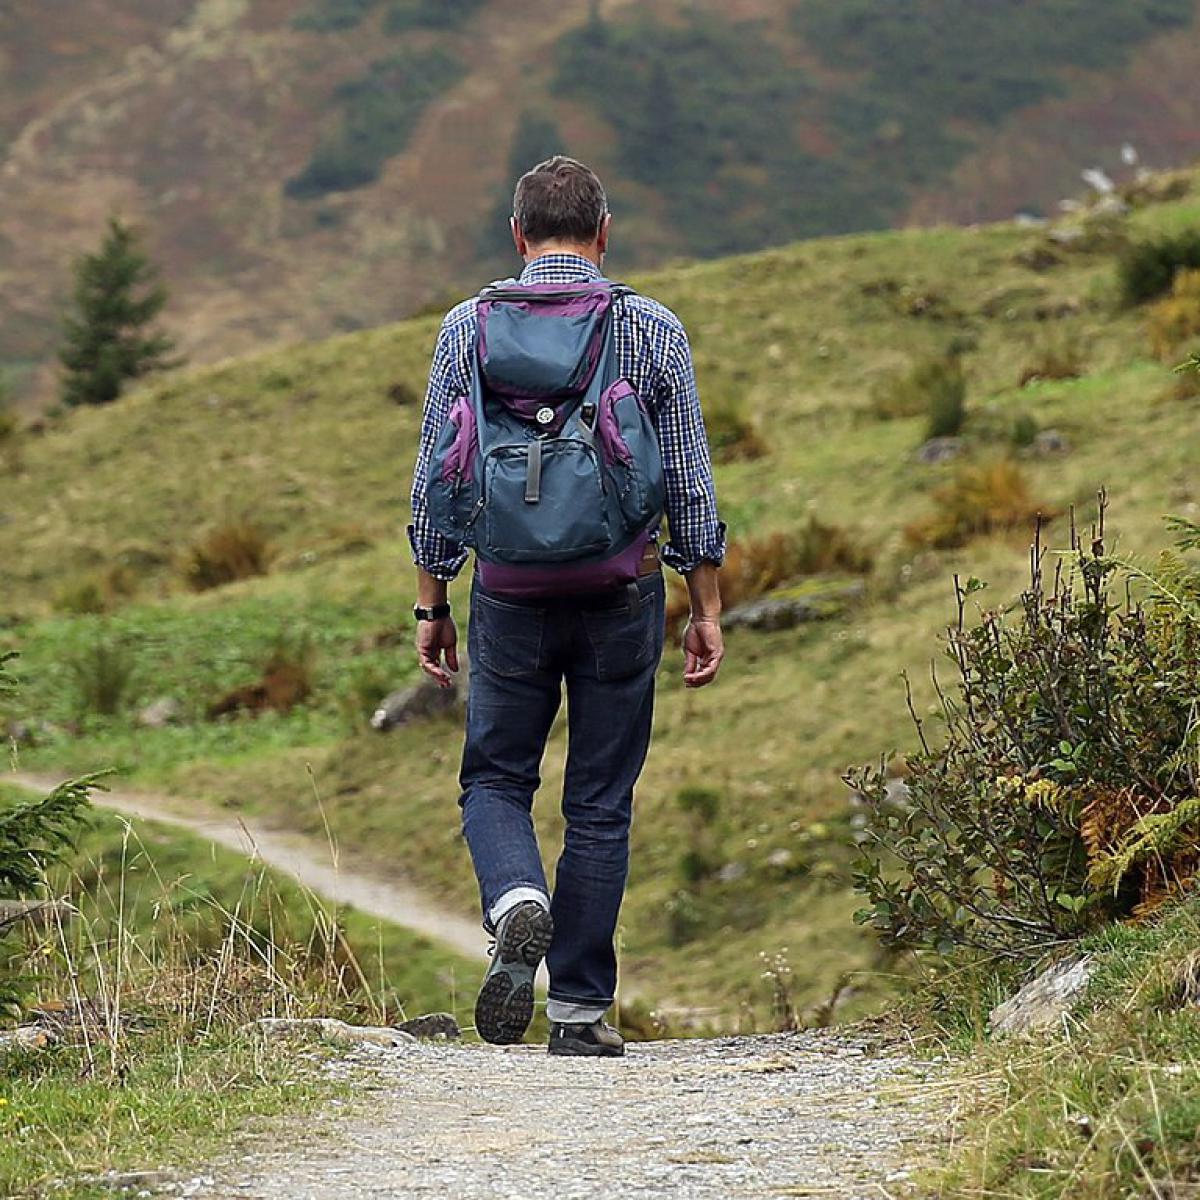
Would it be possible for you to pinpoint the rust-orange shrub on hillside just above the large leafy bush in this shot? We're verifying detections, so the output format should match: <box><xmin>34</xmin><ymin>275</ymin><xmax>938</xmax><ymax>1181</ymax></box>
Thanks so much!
<box><xmin>905</xmin><ymin>458</ymin><xmax>1051</xmax><ymax>550</ymax></box>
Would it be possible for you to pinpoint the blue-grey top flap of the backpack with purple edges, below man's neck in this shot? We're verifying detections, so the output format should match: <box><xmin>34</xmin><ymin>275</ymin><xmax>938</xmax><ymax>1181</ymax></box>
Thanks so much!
<box><xmin>478</xmin><ymin>281</ymin><xmax>613</xmax><ymax>398</ymax></box>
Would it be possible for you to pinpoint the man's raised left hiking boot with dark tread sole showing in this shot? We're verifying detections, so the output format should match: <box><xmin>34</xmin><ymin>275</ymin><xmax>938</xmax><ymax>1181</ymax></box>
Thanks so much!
<box><xmin>475</xmin><ymin>900</ymin><xmax>554</xmax><ymax>1045</ymax></box>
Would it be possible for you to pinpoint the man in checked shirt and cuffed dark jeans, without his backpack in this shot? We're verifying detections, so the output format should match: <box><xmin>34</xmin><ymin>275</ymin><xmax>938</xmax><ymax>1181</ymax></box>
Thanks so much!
<box><xmin>409</xmin><ymin>157</ymin><xmax>725</xmax><ymax>1056</ymax></box>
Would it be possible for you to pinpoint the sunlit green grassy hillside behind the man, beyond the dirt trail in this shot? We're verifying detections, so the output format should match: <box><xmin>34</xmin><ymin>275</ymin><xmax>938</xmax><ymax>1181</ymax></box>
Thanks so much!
<box><xmin>0</xmin><ymin>171</ymin><xmax>1200</xmax><ymax>1026</ymax></box>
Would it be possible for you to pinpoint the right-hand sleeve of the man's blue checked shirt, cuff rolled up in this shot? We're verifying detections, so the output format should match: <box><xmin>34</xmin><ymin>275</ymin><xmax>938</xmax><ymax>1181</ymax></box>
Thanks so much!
<box><xmin>656</xmin><ymin>326</ymin><xmax>725</xmax><ymax>575</ymax></box>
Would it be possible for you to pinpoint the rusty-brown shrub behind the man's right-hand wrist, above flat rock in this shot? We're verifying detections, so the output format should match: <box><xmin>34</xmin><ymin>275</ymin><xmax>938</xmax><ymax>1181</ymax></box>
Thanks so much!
<box><xmin>667</xmin><ymin>516</ymin><xmax>875</xmax><ymax>631</ymax></box>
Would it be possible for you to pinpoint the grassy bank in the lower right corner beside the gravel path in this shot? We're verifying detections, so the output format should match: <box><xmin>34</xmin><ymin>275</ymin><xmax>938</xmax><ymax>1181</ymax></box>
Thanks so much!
<box><xmin>923</xmin><ymin>899</ymin><xmax>1200</xmax><ymax>1200</ymax></box>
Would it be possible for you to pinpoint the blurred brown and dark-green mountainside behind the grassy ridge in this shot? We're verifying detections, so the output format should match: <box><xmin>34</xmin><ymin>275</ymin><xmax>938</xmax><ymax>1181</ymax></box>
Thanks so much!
<box><xmin>0</xmin><ymin>0</ymin><xmax>1200</xmax><ymax>408</ymax></box>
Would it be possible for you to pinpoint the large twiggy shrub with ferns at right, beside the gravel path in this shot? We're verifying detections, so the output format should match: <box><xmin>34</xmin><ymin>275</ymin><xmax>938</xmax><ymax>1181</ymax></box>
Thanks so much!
<box><xmin>847</xmin><ymin>497</ymin><xmax>1200</xmax><ymax>958</ymax></box>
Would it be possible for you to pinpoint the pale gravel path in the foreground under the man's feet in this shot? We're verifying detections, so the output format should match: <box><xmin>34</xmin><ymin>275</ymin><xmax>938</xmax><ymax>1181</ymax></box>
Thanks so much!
<box><xmin>194</xmin><ymin>1033</ymin><xmax>953</xmax><ymax>1200</ymax></box>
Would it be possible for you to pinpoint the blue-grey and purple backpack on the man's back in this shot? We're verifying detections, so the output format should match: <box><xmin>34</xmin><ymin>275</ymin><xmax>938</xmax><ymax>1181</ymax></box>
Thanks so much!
<box><xmin>427</xmin><ymin>280</ymin><xmax>666</xmax><ymax>595</ymax></box>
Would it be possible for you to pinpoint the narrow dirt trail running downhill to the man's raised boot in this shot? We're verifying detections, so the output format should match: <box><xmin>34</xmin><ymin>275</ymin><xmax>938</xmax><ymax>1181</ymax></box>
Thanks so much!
<box><xmin>8</xmin><ymin>772</ymin><xmax>487</xmax><ymax>959</ymax></box>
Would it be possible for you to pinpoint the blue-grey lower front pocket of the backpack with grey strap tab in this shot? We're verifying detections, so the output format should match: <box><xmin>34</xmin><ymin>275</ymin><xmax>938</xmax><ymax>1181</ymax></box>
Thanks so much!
<box><xmin>479</xmin><ymin>438</ymin><xmax>612</xmax><ymax>563</ymax></box>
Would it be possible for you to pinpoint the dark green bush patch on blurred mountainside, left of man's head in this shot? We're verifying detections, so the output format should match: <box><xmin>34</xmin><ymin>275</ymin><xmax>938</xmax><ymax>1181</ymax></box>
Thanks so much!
<box><xmin>284</xmin><ymin>47</ymin><xmax>462</xmax><ymax>200</ymax></box>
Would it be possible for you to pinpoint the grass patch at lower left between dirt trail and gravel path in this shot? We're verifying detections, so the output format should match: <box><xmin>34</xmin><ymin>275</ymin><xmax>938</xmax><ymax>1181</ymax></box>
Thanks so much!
<box><xmin>0</xmin><ymin>785</ymin><xmax>475</xmax><ymax>1196</ymax></box>
